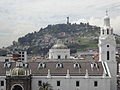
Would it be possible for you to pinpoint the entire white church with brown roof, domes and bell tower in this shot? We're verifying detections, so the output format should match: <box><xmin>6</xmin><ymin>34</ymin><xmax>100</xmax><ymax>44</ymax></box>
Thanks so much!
<box><xmin>0</xmin><ymin>14</ymin><xmax>117</xmax><ymax>90</ymax></box>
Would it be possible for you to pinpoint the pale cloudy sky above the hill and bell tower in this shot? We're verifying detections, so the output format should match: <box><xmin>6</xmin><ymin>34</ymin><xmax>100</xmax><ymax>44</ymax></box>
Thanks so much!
<box><xmin>0</xmin><ymin>0</ymin><xmax>120</xmax><ymax>47</ymax></box>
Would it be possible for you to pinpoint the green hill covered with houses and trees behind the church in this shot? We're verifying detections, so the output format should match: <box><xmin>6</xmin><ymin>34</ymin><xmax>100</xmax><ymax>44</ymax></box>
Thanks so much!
<box><xmin>4</xmin><ymin>23</ymin><xmax>120</xmax><ymax>54</ymax></box>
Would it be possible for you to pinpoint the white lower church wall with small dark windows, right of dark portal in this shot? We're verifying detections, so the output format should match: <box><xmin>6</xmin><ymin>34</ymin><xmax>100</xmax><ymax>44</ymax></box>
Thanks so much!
<box><xmin>32</xmin><ymin>76</ymin><xmax>110</xmax><ymax>90</ymax></box>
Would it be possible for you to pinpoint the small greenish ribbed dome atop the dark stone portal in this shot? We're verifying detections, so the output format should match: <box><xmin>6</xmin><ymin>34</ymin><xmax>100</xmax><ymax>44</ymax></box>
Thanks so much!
<box><xmin>11</xmin><ymin>66</ymin><xmax>25</xmax><ymax>75</ymax></box>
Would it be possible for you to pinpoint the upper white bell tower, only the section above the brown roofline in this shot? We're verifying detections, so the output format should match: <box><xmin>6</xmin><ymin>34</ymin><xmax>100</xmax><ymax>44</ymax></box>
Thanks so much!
<box><xmin>99</xmin><ymin>12</ymin><xmax>116</xmax><ymax>62</ymax></box>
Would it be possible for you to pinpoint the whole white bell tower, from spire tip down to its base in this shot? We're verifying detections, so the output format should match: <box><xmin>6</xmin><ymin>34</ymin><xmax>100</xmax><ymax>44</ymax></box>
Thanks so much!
<box><xmin>99</xmin><ymin>11</ymin><xmax>117</xmax><ymax>90</ymax></box>
